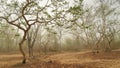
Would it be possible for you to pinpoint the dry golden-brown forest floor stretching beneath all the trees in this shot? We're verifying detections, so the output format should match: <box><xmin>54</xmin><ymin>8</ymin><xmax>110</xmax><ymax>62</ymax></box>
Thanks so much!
<box><xmin>0</xmin><ymin>51</ymin><xmax>120</xmax><ymax>68</ymax></box>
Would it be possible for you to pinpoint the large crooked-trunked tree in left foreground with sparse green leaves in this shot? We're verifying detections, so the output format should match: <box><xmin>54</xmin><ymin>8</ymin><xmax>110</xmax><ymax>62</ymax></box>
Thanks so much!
<box><xmin>0</xmin><ymin>0</ymin><xmax>50</xmax><ymax>63</ymax></box>
